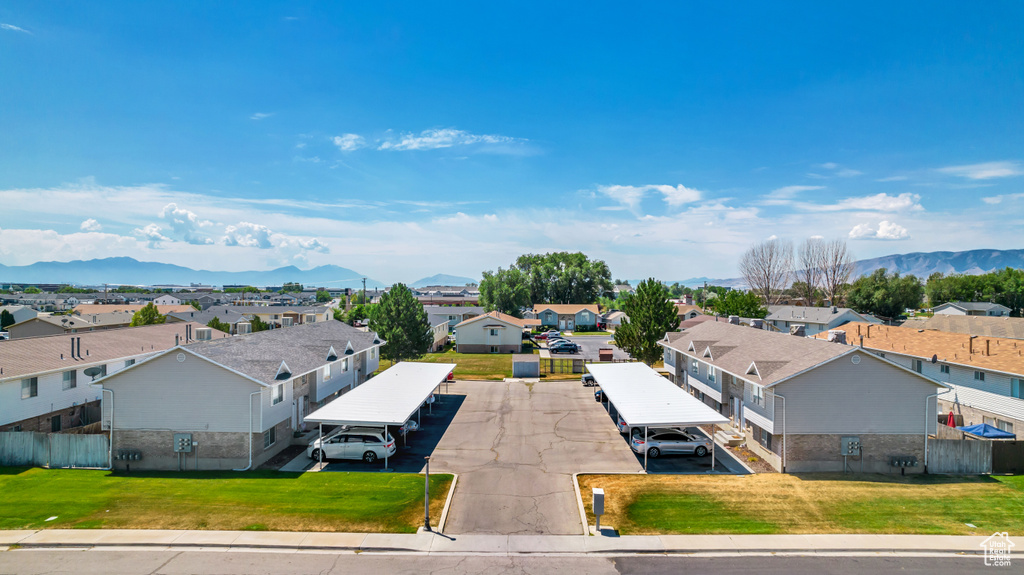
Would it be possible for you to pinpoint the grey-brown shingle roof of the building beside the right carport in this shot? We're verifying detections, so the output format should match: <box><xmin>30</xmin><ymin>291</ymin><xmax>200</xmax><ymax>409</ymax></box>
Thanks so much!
<box><xmin>663</xmin><ymin>321</ymin><xmax>855</xmax><ymax>386</ymax></box>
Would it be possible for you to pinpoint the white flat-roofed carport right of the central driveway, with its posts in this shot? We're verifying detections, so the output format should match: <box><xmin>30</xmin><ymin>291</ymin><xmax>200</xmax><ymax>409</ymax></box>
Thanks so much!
<box><xmin>587</xmin><ymin>362</ymin><xmax>729</xmax><ymax>471</ymax></box>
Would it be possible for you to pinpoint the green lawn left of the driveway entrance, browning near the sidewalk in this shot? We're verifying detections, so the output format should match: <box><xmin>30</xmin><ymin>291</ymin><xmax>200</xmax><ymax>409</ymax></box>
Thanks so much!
<box><xmin>0</xmin><ymin>468</ymin><xmax>452</xmax><ymax>533</ymax></box>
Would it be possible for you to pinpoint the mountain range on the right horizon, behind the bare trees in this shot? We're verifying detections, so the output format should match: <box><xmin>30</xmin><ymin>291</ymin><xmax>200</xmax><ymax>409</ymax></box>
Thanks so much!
<box><xmin>667</xmin><ymin>250</ymin><xmax>1024</xmax><ymax>288</ymax></box>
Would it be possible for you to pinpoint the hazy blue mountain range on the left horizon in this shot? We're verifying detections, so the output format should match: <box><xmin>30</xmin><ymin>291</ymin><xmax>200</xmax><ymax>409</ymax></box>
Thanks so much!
<box><xmin>0</xmin><ymin>258</ymin><xmax>384</xmax><ymax>288</ymax></box>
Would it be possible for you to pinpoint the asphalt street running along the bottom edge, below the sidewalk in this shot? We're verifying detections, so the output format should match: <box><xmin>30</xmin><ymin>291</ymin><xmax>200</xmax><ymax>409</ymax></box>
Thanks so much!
<box><xmin>0</xmin><ymin>549</ymin><xmax>987</xmax><ymax>575</ymax></box>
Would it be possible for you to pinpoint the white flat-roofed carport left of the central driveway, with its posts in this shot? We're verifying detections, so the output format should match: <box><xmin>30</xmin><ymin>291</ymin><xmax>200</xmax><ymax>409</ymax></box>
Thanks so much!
<box><xmin>305</xmin><ymin>361</ymin><xmax>456</xmax><ymax>470</ymax></box>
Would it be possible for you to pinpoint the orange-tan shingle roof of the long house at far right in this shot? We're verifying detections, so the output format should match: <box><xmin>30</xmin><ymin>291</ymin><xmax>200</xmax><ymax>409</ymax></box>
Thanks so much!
<box><xmin>816</xmin><ymin>322</ymin><xmax>1024</xmax><ymax>373</ymax></box>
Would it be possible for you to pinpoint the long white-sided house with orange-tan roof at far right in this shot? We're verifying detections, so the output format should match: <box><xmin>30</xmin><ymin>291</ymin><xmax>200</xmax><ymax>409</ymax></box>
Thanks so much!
<box><xmin>819</xmin><ymin>323</ymin><xmax>1024</xmax><ymax>437</ymax></box>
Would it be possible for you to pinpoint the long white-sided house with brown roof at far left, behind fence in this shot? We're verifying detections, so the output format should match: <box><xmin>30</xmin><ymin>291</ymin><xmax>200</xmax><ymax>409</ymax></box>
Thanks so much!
<box><xmin>0</xmin><ymin>323</ymin><xmax>220</xmax><ymax>432</ymax></box>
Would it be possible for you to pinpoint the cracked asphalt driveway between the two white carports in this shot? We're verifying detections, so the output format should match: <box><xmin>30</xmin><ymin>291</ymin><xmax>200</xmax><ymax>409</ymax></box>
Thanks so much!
<box><xmin>431</xmin><ymin>381</ymin><xmax>641</xmax><ymax>535</ymax></box>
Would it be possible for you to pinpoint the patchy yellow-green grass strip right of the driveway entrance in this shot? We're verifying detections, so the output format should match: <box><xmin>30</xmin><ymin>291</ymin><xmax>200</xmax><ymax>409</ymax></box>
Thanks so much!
<box><xmin>580</xmin><ymin>474</ymin><xmax>1024</xmax><ymax>535</ymax></box>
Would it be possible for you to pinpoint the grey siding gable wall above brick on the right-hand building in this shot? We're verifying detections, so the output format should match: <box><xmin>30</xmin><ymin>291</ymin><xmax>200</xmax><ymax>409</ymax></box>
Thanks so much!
<box><xmin>774</xmin><ymin>353</ymin><xmax>940</xmax><ymax>433</ymax></box>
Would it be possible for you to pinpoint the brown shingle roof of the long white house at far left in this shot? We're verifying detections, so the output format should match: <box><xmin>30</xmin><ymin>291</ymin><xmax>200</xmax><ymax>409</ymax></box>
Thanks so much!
<box><xmin>0</xmin><ymin>322</ymin><xmax>222</xmax><ymax>381</ymax></box>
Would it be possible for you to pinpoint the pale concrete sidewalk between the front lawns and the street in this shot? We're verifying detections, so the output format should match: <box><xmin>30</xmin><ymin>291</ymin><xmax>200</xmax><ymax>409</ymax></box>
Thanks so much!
<box><xmin>0</xmin><ymin>529</ymin><xmax>986</xmax><ymax>555</ymax></box>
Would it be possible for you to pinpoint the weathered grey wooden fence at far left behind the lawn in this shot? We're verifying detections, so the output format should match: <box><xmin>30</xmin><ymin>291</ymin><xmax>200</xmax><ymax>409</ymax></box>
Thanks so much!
<box><xmin>0</xmin><ymin>432</ymin><xmax>111</xmax><ymax>469</ymax></box>
